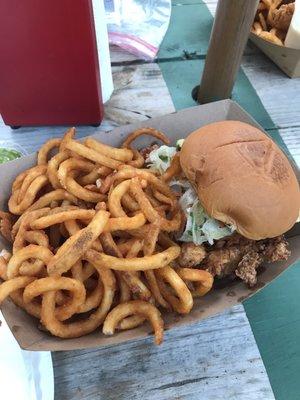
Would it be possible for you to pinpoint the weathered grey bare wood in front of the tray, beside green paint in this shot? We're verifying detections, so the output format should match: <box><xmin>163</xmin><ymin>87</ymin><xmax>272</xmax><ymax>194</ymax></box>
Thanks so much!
<box><xmin>52</xmin><ymin>306</ymin><xmax>274</xmax><ymax>400</ymax></box>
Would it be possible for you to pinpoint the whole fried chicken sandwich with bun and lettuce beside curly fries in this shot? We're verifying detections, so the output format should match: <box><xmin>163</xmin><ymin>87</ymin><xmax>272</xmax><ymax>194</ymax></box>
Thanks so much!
<box><xmin>149</xmin><ymin>121</ymin><xmax>300</xmax><ymax>286</ymax></box>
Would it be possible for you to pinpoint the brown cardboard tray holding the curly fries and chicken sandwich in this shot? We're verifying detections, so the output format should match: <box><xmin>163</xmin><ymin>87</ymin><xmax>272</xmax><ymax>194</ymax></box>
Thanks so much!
<box><xmin>0</xmin><ymin>100</ymin><xmax>300</xmax><ymax>351</ymax></box>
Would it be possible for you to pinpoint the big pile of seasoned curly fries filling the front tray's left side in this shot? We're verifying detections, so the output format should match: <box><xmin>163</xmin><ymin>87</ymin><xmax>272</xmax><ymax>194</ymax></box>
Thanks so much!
<box><xmin>0</xmin><ymin>125</ymin><xmax>216</xmax><ymax>344</ymax></box>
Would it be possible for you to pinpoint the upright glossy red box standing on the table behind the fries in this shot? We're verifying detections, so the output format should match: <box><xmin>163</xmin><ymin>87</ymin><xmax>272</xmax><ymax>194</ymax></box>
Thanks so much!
<box><xmin>0</xmin><ymin>0</ymin><xmax>103</xmax><ymax>126</ymax></box>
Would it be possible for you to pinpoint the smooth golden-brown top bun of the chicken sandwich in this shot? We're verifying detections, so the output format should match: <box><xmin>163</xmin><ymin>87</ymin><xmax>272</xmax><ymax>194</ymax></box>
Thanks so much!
<box><xmin>180</xmin><ymin>121</ymin><xmax>300</xmax><ymax>240</ymax></box>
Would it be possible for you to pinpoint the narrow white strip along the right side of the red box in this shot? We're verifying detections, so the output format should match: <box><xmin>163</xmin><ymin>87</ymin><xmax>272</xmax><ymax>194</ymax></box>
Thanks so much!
<box><xmin>92</xmin><ymin>0</ymin><xmax>114</xmax><ymax>103</ymax></box>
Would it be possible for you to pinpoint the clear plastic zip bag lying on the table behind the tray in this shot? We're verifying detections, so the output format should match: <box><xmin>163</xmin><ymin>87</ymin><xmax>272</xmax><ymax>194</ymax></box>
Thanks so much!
<box><xmin>104</xmin><ymin>0</ymin><xmax>171</xmax><ymax>60</ymax></box>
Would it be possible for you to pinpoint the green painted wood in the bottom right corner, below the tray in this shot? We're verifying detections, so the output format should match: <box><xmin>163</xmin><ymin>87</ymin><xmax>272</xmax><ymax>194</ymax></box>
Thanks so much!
<box><xmin>244</xmin><ymin>262</ymin><xmax>300</xmax><ymax>400</ymax></box>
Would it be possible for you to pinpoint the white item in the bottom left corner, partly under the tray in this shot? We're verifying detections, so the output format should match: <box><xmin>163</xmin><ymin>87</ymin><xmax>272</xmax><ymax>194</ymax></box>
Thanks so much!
<box><xmin>0</xmin><ymin>312</ymin><xmax>54</xmax><ymax>400</ymax></box>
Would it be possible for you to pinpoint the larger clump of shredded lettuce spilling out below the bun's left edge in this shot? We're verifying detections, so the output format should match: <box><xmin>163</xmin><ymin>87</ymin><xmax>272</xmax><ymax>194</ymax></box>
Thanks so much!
<box><xmin>179</xmin><ymin>185</ymin><xmax>234</xmax><ymax>245</ymax></box>
